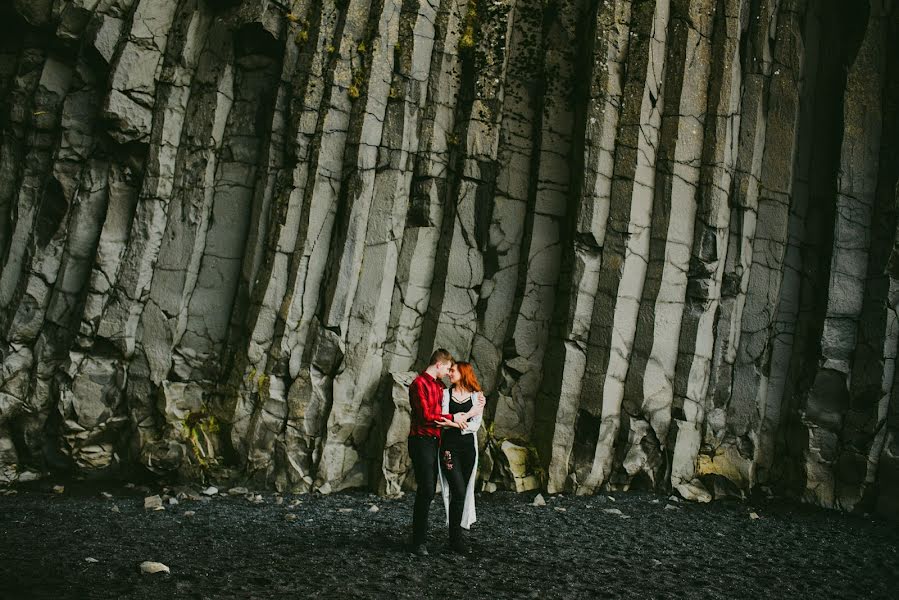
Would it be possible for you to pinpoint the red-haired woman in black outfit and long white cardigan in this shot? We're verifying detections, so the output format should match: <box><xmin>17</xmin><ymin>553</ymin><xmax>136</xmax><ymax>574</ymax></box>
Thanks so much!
<box><xmin>440</xmin><ymin>362</ymin><xmax>484</xmax><ymax>554</ymax></box>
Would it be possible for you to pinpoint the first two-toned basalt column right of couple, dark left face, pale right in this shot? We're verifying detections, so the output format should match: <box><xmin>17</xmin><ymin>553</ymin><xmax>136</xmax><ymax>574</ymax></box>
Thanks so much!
<box><xmin>574</xmin><ymin>0</ymin><xmax>670</xmax><ymax>493</ymax></box>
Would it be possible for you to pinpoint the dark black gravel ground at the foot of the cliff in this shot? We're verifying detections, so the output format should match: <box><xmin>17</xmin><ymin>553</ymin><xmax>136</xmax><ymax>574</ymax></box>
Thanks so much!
<box><xmin>0</xmin><ymin>482</ymin><xmax>899</xmax><ymax>599</ymax></box>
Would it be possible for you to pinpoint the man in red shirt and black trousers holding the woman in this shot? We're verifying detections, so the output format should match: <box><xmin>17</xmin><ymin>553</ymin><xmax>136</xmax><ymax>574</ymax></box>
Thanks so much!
<box><xmin>409</xmin><ymin>348</ymin><xmax>465</xmax><ymax>556</ymax></box>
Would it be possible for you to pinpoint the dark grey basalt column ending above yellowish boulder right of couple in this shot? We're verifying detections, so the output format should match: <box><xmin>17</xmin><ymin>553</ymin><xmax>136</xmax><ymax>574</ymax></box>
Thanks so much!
<box><xmin>494</xmin><ymin>2</ymin><xmax>587</xmax><ymax>442</ymax></box>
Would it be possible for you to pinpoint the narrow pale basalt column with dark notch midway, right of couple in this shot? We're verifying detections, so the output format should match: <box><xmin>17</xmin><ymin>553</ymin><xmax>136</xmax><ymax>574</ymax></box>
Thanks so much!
<box><xmin>535</xmin><ymin>0</ymin><xmax>631</xmax><ymax>493</ymax></box>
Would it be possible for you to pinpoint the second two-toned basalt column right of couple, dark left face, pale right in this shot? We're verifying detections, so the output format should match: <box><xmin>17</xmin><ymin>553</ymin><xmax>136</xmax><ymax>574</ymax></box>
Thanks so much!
<box><xmin>620</xmin><ymin>0</ymin><xmax>714</xmax><ymax>486</ymax></box>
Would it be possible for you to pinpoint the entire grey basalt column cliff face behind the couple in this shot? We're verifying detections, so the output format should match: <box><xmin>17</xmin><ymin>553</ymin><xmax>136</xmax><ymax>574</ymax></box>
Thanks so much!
<box><xmin>0</xmin><ymin>0</ymin><xmax>899</xmax><ymax>517</ymax></box>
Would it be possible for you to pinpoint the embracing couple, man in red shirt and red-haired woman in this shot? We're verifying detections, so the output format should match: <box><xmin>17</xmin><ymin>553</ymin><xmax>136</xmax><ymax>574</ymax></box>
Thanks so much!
<box><xmin>409</xmin><ymin>348</ymin><xmax>485</xmax><ymax>556</ymax></box>
